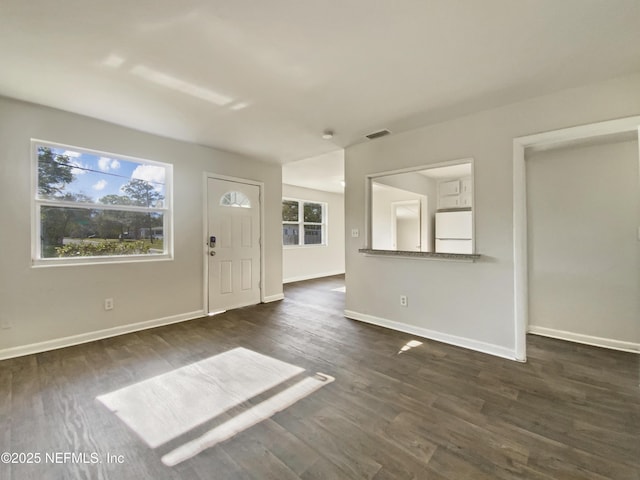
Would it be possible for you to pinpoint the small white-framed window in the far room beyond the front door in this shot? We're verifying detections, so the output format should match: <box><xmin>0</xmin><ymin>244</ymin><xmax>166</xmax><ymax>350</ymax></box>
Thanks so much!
<box><xmin>282</xmin><ymin>199</ymin><xmax>327</xmax><ymax>245</ymax></box>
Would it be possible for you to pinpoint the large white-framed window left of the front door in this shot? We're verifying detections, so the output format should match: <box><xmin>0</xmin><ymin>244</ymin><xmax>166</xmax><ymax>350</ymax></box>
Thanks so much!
<box><xmin>32</xmin><ymin>141</ymin><xmax>172</xmax><ymax>265</ymax></box>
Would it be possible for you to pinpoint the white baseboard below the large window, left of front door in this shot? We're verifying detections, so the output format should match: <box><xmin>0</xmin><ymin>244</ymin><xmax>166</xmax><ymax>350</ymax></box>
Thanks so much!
<box><xmin>0</xmin><ymin>310</ymin><xmax>206</xmax><ymax>360</ymax></box>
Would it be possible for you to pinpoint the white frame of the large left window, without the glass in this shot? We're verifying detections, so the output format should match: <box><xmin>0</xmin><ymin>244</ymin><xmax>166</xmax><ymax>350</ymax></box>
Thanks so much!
<box><xmin>31</xmin><ymin>138</ymin><xmax>173</xmax><ymax>267</ymax></box>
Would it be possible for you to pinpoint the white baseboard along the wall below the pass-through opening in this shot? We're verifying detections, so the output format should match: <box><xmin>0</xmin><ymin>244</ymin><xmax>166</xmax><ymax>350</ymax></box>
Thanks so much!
<box><xmin>344</xmin><ymin>310</ymin><xmax>519</xmax><ymax>361</ymax></box>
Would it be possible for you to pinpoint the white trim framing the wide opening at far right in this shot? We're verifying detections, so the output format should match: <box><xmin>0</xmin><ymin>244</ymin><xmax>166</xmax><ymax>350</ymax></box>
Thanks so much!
<box><xmin>513</xmin><ymin>116</ymin><xmax>640</xmax><ymax>362</ymax></box>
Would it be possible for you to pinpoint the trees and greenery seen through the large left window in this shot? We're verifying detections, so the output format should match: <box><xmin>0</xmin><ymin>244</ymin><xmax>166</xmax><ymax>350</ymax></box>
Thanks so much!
<box><xmin>37</xmin><ymin>146</ymin><xmax>164</xmax><ymax>258</ymax></box>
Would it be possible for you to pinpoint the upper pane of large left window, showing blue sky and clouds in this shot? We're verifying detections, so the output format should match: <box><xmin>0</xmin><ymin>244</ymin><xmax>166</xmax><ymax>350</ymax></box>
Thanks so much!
<box><xmin>37</xmin><ymin>145</ymin><xmax>166</xmax><ymax>208</ymax></box>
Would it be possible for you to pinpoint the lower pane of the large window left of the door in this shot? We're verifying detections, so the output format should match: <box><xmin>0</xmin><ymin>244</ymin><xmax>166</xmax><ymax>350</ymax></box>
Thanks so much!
<box><xmin>40</xmin><ymin>206</ymin><xmax>164</xmax><ymax>258</ymax></box>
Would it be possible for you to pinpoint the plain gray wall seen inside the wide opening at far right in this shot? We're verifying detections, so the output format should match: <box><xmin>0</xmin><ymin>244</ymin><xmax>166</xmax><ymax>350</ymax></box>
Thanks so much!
<box><xmin>526</xmin><ymin>139</ymin><xmax>640</xmax><ymax>350</ymax></box>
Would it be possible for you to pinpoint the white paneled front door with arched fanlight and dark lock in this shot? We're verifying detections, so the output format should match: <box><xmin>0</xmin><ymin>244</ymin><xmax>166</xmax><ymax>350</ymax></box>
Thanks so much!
<box><xmin>206</xmin><ymin>178</ymin><xmax>261</xmax><ymax>313</ymax></box>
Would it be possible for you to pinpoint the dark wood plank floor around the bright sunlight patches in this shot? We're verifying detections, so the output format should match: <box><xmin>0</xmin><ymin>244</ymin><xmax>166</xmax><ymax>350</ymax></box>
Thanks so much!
<box><xmin>0</xmin><ymin>277</ymin><xmax>640</xmax><ymax>480</ymax></box>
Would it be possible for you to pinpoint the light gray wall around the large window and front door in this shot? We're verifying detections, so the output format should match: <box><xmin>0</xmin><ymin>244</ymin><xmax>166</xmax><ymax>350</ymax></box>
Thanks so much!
<box><xmin>0</xmin><ymin>98</ymin><xmax>282</xmax><ymax>354</ymax></box>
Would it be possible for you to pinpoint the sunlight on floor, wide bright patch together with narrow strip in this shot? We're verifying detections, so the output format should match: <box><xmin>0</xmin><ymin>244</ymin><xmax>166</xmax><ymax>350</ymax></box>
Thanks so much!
<box><xmin>97</xmin><ymin>348</ymin><xmax>334</xmax><ymax>465</ymax></box>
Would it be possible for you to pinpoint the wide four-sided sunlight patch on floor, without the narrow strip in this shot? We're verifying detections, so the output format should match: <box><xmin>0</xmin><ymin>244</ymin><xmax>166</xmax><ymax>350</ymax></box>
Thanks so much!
<box><xmin>97</xmin><ymin>348</ymin><xmax>305</xmax><ymax>448</ymax></box>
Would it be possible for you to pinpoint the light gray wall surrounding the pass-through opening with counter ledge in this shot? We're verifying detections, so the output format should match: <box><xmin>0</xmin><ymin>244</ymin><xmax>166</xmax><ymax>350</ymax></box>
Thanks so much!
<box><xmin>345</xmin><ymin>70</ymin><xmax>640</xmax><ymax>358</ymax></box>
